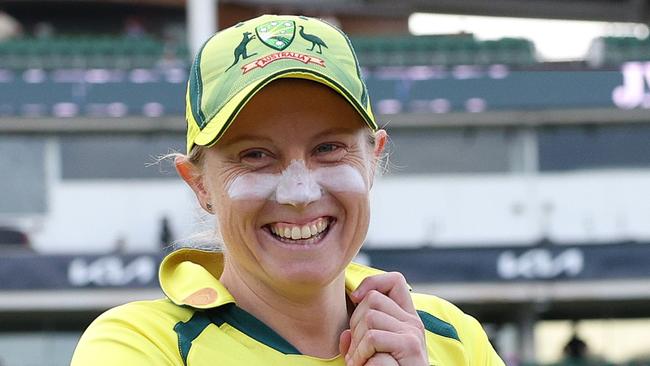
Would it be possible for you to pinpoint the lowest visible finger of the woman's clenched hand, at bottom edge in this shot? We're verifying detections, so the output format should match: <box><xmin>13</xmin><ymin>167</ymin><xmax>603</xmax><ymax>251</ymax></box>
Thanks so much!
<box><xmin>349</xmin><ymin>329</ymin><xmax>426</xmax><ymax>366</ymax></box>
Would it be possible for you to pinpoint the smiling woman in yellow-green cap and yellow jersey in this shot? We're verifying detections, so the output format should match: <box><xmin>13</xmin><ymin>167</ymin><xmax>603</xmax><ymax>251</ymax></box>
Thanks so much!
<box><xmin>72</xmin><ymin>15</ymin><xmax>503</xmax><ymax>366</ymax></box>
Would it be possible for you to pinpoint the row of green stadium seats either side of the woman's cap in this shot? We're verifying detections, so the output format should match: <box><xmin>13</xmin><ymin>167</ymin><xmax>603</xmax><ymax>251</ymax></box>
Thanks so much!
<box><xmin>0</xmin><ymin>35</ymin><xmax>536</xmax><ymax>69</ymax></box>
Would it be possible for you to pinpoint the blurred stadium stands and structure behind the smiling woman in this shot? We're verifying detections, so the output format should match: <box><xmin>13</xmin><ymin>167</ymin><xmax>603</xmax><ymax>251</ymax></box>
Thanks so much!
<box><xmin>0</xmin><ymin>0</ymin><xmax>650</xmax><ymax>366</ymax></box>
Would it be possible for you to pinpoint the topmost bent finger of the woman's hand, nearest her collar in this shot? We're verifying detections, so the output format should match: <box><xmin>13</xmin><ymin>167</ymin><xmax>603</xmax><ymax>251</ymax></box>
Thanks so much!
<box><xmin>350</xmin><ymin>272</ymin><xmax>415</xmax><ymax>314</ymax></box>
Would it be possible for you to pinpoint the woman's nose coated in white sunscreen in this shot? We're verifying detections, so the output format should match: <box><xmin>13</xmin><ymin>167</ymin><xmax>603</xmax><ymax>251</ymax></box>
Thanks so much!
<box><xmin>275</xmin><ymin>160</ymin><xmax>322</xmax><ymax>207</ymax></box>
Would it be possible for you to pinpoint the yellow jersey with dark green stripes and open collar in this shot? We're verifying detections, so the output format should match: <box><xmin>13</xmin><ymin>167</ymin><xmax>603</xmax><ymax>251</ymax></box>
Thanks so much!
<box><xmin>71</xmin><ymin>248</ymin><xmax>504</xmax><ymax>366</ymax></box>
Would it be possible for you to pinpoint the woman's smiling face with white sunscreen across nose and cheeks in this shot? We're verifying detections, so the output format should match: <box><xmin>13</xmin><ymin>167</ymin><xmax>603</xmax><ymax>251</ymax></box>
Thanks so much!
<box><xmin>187</xmin><ymin>79</ymin><xmax>386</xmax><ymax>287</ymax></box>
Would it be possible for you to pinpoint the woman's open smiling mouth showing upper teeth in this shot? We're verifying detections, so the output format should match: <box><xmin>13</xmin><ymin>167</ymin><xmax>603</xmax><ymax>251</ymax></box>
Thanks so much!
<box><xmin>263</xmin><ymin>216</ymin><xmax>336</xmax><ymax>245</ymax></box>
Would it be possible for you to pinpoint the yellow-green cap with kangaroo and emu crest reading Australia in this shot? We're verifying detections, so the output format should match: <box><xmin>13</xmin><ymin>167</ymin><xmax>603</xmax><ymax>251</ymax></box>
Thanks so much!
<box><xmin>185</xmin><ymin>15</ymin><xmax>378</xmax><ymax>154</ymax></box>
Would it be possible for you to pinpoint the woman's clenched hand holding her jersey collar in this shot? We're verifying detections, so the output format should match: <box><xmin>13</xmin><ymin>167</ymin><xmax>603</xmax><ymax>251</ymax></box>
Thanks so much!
<box><xmin>339</xmin><ymin>272</ymin><xmax>428</xmax><ymax>366</ymax></box>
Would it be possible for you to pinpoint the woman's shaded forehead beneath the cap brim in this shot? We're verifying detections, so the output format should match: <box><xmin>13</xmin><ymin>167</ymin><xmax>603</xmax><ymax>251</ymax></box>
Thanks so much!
<box><xmin>217</xmin><ymin>79</ymin><xmax>368</xmax><ymax>142</ymax></box>
